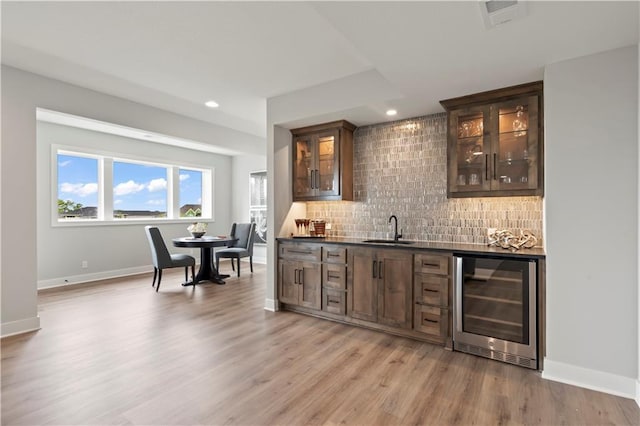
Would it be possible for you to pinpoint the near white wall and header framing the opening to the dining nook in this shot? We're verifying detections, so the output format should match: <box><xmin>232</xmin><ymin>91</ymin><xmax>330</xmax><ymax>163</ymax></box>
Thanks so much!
<box><xmin>0</xmin><ymin>66</ymin><xmax>265</xmax><ymax>336</ymax></box>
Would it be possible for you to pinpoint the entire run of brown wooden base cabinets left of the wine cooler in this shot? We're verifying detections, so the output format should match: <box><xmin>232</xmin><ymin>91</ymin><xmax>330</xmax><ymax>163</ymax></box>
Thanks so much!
<box><xmin>278</xmin><ymin>241</ymin><xmax>453</xmax><ymax>348</ymax></box>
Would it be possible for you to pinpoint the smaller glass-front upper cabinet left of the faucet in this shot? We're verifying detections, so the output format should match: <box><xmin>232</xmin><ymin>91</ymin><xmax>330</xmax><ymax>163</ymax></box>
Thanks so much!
<box><xmin>291</xmin><ymin>120</ymin><xmax>355</xmax><ymax>201</ymax></box>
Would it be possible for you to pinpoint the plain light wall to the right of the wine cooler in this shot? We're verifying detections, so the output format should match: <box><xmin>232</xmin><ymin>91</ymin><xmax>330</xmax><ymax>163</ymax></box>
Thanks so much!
<box><xmin>544</xmin><ymin>46</ymin><xmax>638</xmax><ymax>397</ymax></box>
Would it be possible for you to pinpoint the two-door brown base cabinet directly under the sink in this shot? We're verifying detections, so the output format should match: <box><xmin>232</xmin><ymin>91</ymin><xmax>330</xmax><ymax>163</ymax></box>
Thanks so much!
<box><xmin>348</xmin><ymin>248</ymin><xmax>413</xmax><ymax>329</ymax></box>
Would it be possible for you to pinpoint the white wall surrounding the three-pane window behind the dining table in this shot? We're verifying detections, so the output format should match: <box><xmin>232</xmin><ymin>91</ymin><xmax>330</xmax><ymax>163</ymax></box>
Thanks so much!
<box><xmin>37</xmin><ymin>122</ymin><xmax>232</xmax><ymax>288</ymax></box>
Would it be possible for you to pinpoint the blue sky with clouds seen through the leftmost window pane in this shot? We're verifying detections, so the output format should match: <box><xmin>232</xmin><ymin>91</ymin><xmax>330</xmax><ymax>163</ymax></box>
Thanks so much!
<box><xmin>58</xmin><ymin>154</ymin><xmax>98</xmax><ymax>207</ymax></box>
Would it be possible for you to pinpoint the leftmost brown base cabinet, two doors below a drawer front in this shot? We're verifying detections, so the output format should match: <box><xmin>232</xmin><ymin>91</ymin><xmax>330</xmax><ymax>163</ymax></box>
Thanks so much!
<box><xmin>278</xmin><ymin>244</ymin><xmax>322</xmax><ymax>310</ymax></box>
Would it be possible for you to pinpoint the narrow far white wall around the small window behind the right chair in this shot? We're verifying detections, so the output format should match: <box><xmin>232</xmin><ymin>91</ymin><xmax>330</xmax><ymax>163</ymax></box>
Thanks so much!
<box><xmin>227</xmin><ymin>154</ymin><xmax>268</xmax><ymax>263</ymax></box>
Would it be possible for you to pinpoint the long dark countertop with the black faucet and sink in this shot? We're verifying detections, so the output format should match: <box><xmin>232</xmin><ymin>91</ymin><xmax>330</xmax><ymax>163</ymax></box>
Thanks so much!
<box><xmin>276</xmin><ymin>237</ymin><xmax>545</xmax><ymax>258</ymax></box>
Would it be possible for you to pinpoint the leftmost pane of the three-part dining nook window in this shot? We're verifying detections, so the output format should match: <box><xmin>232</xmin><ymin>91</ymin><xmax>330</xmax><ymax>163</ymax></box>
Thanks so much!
<box><xmin>56</xmin><ymin>153</ymin><xmax>98</xmax><ymax>219</ymax></box>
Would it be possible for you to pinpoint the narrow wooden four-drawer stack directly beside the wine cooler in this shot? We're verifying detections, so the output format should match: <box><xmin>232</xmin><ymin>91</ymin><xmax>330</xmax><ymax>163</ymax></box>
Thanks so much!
<box><xmin>413</xmin><ymin>253</ymin><xmax>451</xmax><ymax>347</ymax></box>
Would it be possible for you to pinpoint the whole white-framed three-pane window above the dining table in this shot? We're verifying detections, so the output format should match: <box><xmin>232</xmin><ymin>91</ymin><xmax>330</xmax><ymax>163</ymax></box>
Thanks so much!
<box><xmin>53</xmin><ymin>147</ymin><xmax>213</xmax><ymax>223</ymax></box>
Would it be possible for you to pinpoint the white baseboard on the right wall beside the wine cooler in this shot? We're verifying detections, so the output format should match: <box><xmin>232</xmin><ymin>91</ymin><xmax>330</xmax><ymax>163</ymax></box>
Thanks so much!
<box><xmin>542</xmin><ymin>358</ymin><xmax>638</xmax><ymax>402</ymax></box>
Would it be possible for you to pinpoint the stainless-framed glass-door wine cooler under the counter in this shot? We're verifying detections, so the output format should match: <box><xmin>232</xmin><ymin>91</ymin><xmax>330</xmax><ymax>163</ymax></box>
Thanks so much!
<box><xmin>453</xmin><ymin>254</ymin><xmax>538</xmax><ymax>369</ymax></box>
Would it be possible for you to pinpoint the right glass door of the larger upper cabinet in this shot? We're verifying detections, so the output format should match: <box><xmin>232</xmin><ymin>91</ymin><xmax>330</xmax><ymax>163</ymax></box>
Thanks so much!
<box><xmin>492</xmin><ymin>96</ymin><xmax>538</xmax><ymax>191</ymax></box>
